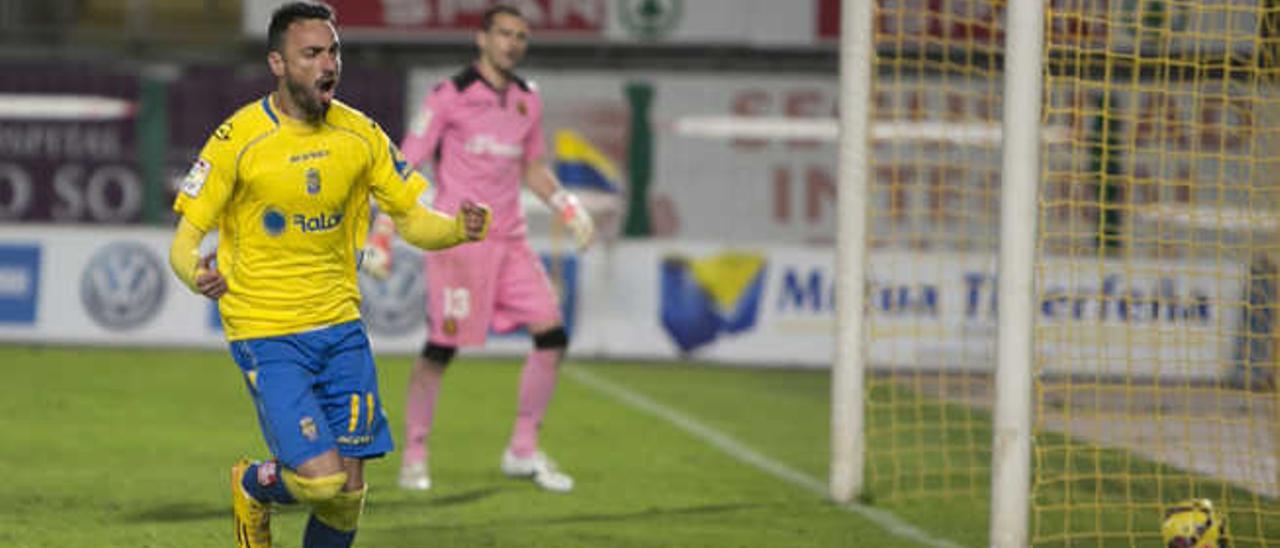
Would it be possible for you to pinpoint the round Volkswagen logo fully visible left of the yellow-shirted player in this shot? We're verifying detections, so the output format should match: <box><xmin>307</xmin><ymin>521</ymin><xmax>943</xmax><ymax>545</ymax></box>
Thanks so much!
<box><xmin>81</xmin><ymin>242</ymin><xmax>165</xmax><ymax>330</ymax></box>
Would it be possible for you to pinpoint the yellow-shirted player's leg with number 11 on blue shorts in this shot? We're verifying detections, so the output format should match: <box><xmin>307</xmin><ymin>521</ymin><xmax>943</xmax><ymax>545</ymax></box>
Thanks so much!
<box><xmin>298</xmin><ymin>321</ymin><xmax>394</xmax><ymax>547</ymax></box>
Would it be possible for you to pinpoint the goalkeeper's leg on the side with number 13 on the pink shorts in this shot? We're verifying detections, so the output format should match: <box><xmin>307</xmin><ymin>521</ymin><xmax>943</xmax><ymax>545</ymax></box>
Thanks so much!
<box><xmin>398</xmin><ymin>242</ymin><xmax>500</xmax><ymax>489</ymax></box>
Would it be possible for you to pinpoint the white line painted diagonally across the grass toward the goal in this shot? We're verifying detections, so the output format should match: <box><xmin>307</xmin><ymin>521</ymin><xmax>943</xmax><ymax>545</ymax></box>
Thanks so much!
<box><xmin>564</xmin><ymin>367</ymin><xmax>960</xmax><ymax>548</ymax></box>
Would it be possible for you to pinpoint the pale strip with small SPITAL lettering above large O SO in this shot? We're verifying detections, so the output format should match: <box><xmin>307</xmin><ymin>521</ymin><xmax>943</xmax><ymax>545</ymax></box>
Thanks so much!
<box><xmin>0</xmin><ymin>124</ymin><xmax>124</xmax><ymax>160</ymax></box>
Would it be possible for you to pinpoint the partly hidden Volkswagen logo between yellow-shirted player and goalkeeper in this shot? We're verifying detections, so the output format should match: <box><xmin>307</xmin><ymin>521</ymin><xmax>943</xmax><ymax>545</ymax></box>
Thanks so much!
<box><xmin>360</xmin><ymin>242</ymin><xmax>426</xmax><ymax>335</ymax></box>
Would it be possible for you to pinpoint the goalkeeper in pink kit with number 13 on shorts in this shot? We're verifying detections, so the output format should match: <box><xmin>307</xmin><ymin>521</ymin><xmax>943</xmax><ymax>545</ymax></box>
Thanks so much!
<box><xmin>381</xmin><ymin>5</ymin><xmax>593</xmax><ymax>492</ymax></box>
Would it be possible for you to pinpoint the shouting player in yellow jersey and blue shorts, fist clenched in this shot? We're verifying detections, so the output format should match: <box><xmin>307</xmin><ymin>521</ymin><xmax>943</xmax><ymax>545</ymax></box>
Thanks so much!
<box><xmin>169</xmin><ymin>3</ymin><xmax>489</xmax><ymax>548</ymax></box>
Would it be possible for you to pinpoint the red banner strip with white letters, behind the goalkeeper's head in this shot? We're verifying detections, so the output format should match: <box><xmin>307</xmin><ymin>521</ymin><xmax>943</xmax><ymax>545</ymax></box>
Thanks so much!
<box><xmin>329</xmin><ymin>0</ymin><xmax>608</xmax><ymax>40</ymax></box>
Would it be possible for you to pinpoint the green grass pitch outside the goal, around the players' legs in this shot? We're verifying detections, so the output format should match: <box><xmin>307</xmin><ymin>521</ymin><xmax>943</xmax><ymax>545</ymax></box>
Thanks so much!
<box><xmin>0</xmin><ymin>344</ymin><xmax>1269</xmax><ymax>547</ymax></box>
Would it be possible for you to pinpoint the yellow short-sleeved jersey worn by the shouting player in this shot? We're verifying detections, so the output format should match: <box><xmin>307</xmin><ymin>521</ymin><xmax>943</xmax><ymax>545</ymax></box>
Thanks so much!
<box><xmin>173</xmin><ymin>95</ymin><xmax>429</xmax><ymax>341</ymax></box>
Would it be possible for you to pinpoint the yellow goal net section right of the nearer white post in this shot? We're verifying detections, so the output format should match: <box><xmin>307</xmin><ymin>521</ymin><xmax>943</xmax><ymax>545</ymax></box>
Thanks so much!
<box><xmin>1029</xmin><ymin>0</ymin><xmax>1280</xmax><ymax>545</ymax></box>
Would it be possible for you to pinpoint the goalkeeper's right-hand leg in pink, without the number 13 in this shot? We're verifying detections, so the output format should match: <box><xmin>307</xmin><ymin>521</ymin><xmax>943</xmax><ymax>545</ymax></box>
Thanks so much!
<box><xmin>494</xmin><ymin>242</ymin><xmax>573</xmax><ymax>492</ymax></box>
